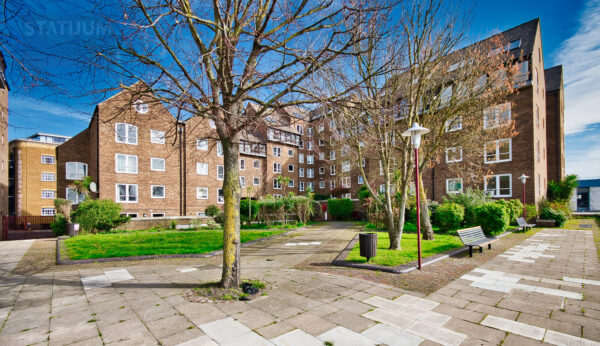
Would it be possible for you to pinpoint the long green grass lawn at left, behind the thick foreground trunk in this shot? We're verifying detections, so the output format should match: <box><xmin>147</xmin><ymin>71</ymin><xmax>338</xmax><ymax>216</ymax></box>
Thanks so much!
<box><xmin>65</xmin><ymin>231</ymin><xmax>284</xmax><ymax>260</ymax></box>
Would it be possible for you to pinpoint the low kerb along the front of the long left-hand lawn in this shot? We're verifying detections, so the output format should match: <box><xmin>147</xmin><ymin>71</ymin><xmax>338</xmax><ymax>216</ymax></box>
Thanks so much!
<box><xmin>56</xmin><ymin>227</ymin><xmax>296</xmax><ymax>265</ymax></box>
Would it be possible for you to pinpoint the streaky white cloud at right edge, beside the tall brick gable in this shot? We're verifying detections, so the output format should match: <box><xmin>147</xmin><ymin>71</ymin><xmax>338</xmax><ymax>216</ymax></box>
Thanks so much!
<box><xmin>554</xmin><ymin>0</ymin><xmax>600</xmax><ymax>134</ymax></box>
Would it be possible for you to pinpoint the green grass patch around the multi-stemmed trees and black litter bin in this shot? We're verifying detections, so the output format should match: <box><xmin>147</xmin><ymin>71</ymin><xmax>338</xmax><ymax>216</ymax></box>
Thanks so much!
<box><xmin>346</xmin><ymin>232</ymin><xmax>463</xmax><ymax>266</ymax></box>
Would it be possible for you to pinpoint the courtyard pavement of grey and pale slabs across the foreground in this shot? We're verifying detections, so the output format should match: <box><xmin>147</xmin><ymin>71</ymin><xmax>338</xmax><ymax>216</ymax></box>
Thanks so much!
<box><xmin>0</xmin><ymin>223</ymin><xmax>600</xmax><ymax>345</ymax></box>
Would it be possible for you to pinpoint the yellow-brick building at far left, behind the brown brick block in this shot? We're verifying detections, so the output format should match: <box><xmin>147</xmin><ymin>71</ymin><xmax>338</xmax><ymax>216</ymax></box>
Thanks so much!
<box><xmin>8</xmin><ymin>133</ymin><xmax>70</xmax><ymax>216</ymax></box>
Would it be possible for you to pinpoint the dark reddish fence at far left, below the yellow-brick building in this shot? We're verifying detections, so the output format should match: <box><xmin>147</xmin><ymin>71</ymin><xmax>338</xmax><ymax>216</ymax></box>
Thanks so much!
<box><xmin>2</xmin><ymin>215</ymin><xmax>54</xmax><ymax>240</ymax></box>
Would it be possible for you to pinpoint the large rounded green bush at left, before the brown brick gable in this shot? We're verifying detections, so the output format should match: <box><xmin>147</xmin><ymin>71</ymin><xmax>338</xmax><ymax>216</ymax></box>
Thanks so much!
<box><xmin>71</xmin><ymin>199</ymin><xmax>129</xmax><ymax>233</ymax></box>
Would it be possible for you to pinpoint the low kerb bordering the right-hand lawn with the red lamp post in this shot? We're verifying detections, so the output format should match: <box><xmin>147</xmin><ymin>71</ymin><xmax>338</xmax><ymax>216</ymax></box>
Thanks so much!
<box><xmin>331</xmin><ymin>230</ymin><xmax>514</xmax><ymax>274</ymax></box>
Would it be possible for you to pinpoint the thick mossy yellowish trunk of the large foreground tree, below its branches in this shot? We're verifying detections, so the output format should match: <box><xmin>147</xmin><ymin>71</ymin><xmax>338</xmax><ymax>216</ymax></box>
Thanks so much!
<box><xmin>221</xmin><ymin>137</ymin><xmax>241</xmax><ymax>288</ymax></box>
